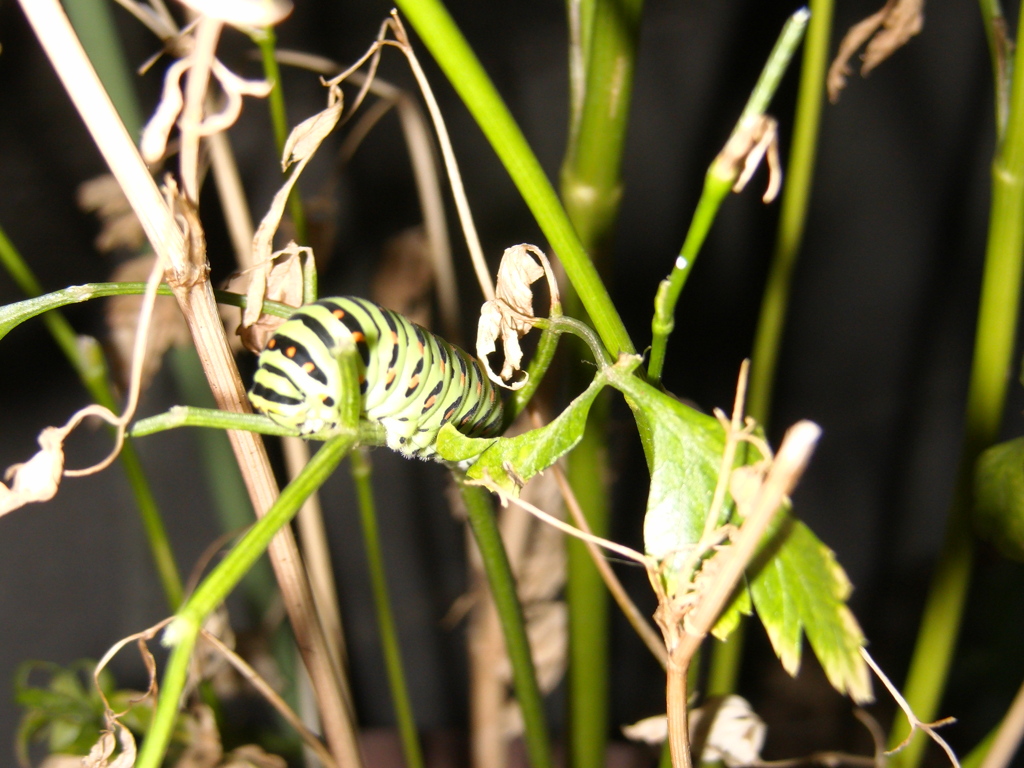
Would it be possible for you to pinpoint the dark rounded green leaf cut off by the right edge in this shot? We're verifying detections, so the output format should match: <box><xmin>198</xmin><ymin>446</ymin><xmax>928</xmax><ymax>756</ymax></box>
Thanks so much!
<box><xmin>974</xmin><ymin>437</ymin><xmax>1024</xmax><ymax>561</ymax></box>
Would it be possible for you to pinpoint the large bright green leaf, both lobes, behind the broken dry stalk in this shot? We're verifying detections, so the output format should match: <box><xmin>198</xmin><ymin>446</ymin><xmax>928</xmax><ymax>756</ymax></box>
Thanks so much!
<box><xmin>609</xmin><ymin>364</ymin><xmax>871</xmax><ymax>701</ymax></box>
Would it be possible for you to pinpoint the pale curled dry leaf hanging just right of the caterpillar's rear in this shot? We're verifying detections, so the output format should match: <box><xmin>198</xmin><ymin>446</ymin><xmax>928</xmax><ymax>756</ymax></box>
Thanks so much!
<box><xmin>476</xmin><ymin>243</ymin><xmax>558</xmax><ymax>389</ymax></box>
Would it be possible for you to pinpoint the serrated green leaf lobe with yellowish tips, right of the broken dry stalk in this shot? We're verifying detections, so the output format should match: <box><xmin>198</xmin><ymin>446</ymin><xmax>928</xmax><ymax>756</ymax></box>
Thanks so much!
<box><xmin>748</xmin><ymin>515</ymin><xmax>873</xmax><ymax>702</ymax></box>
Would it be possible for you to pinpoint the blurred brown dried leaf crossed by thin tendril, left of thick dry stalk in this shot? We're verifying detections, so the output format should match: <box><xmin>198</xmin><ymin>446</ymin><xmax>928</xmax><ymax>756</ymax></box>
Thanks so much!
<box><xmin>104</xmin><ymin>259</ymin><xmax>191</xmax><ymax>389</ymax></box>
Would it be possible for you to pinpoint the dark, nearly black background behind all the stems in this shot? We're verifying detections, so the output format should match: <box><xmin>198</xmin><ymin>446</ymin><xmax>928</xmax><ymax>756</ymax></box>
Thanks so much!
<box><xmin>0</xmin><ymin>0</ymin><xmax>1024</xmax><ymax>763</ymax></box>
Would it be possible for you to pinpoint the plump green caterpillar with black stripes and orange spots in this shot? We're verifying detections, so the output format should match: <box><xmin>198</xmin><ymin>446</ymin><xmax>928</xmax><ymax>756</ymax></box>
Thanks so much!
<box><xmin>249</xmin><ymin>296</ymin><xmax>502</xmax><ymax>459</ymax></box>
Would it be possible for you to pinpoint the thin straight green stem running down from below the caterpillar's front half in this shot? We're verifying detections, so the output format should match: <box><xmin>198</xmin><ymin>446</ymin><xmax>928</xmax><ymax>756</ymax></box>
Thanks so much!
<box><xmin>349</xmin><ymin>451</ymin><xmax>423</xmax><ymax>768</ymax></box>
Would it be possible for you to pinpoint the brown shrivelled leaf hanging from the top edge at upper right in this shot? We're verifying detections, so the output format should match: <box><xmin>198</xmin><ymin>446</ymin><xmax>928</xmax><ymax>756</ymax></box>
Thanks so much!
<box><xmin>826</xmin><ymin>0</ymin><xmax>925</xmax><ymax>103</ymax></box>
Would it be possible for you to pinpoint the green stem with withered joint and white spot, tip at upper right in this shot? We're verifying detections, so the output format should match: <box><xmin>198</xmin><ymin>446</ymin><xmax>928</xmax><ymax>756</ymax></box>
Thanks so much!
<box><xmin>647</xmin><ymin>8</ymin><xmax>809</xmax><ymax>384</ymax></box>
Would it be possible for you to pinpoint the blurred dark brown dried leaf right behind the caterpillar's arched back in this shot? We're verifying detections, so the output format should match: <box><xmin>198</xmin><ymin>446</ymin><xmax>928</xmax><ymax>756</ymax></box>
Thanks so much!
<box><xmin>370</xmin><ymin>226</ymin><xmax>434</xmax><ymax>328</ymax></box>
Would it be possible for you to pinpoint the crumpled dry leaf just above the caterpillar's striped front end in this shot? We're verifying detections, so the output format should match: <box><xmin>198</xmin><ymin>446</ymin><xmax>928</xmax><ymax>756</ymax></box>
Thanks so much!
<box><xmin>234</xmin><ymin>241</ymin><xmax>313</xmax><ymax>353</ymax></box>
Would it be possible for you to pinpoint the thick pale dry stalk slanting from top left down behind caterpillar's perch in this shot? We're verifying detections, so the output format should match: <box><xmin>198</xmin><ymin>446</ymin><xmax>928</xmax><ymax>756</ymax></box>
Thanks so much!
<box><xmin>20</xmin><ymin>0</ymin><xmax>361</xmax><ymax>766</ymax></box>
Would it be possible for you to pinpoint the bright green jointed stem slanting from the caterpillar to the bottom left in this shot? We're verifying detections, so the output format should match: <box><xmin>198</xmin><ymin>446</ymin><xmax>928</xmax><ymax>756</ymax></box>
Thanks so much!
<box><xmin>136</xmin><ymin>435</ymin><xmax>353</xmax><ymax>768</ymax></box>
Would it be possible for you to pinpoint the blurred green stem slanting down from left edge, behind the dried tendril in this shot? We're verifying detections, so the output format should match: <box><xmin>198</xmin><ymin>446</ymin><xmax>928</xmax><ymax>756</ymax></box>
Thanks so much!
<box><xmin>0</xmin><ymin>228</ymin><xmax>183</xmax><ymax>610</ymax></box>
